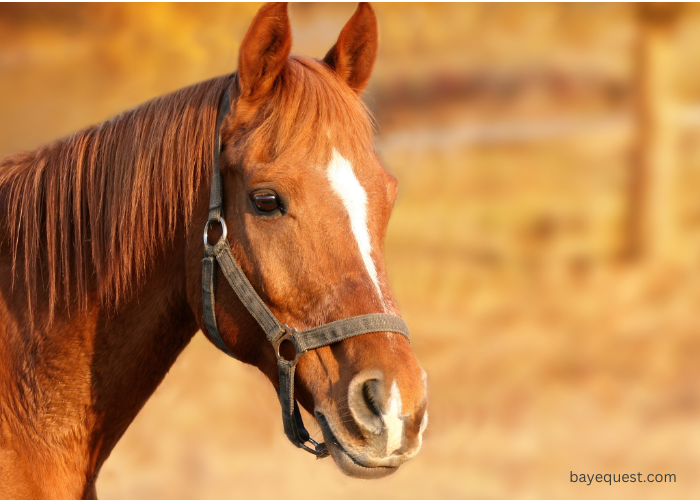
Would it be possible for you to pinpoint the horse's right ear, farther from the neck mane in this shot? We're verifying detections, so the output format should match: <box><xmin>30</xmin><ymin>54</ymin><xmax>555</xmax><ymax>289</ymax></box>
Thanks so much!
<box><xmin>323</xmin><ymin>2</ymin><xmax>379</xmax><ymax>94</ymax></box>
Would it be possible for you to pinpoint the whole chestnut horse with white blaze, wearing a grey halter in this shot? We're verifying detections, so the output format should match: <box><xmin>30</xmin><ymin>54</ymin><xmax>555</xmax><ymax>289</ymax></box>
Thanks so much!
<box><xmin>0</xmin><ymin>3</ymin><xmax>427</xmax><ymax>500</ymax></box>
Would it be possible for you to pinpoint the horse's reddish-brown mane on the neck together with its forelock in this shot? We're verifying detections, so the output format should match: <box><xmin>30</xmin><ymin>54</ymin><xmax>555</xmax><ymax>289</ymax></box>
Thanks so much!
<box><xmin>0</xmin><ymin>57</ymin><xmax>374</xmax><ymax>321</ymax></box>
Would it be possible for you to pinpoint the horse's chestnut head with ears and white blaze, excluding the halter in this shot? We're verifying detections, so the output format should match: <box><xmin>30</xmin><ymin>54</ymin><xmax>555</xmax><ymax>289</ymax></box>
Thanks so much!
<box><xmin>200</xmin><ymin>4</ymin><xmax>427</xmax><ymax>478</ymax></box>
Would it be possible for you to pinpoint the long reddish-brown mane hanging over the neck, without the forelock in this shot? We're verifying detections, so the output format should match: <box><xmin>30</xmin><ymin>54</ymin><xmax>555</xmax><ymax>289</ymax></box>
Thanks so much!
<box><xmin>0</xmin><ymin>76</ymin><xmax>231</xmax><ymax>321</ymax></box>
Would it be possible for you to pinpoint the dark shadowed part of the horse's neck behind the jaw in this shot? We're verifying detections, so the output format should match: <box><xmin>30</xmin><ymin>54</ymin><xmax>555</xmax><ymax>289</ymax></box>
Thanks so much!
<box><xmin>91</xmin><ymin>236</ymin><xmax>198</xmax><ymax>460</ymax></box>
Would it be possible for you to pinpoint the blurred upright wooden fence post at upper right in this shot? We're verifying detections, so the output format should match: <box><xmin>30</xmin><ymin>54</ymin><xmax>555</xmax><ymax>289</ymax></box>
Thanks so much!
<box><xmin>628</xmin><ymin>2</ymin><xmax>681</xmax><ymax>263</ymax></box>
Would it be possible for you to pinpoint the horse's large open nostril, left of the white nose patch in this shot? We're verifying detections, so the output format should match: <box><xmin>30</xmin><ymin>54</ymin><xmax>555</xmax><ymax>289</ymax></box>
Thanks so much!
<box><xmin>348</xmin><ymin>370</ymin><xmax>385</xmax><ymax>434</ymax></box>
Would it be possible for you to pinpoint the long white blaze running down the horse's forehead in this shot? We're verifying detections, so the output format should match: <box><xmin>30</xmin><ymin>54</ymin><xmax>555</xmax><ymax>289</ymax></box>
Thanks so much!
<box><xmin>328</xmin><ymin>148</ymin><xmax>382</xmax><ymax>300</ymax></box>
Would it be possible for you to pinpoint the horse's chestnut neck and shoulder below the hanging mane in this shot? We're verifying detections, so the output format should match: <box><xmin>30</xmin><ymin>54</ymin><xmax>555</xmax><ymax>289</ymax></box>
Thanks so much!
<box><xmin>0</xmin><ymin>189</ymin><xmax>198</xmax><ymax>491</ymax></box>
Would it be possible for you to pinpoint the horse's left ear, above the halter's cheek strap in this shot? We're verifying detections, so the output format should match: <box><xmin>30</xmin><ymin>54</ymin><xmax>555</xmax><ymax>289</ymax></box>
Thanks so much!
<box><xmin>238</xmin><ymin>2</ymin><xmax>292</xmax><ymax>99</ymax></box>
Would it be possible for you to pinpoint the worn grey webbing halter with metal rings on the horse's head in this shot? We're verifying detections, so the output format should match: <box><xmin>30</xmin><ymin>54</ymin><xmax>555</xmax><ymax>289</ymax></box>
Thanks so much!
<box><xmin>202</xmin><ymin>89</ymin><xmax>409</xmax><ymax>458</ymax></box>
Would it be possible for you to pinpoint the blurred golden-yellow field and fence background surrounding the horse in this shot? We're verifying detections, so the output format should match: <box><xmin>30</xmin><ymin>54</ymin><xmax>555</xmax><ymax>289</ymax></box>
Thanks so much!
<box><xmin>0</xmin><ymin>3</ymin><xmax>700</xmax><ymax>500</ymax></box>
